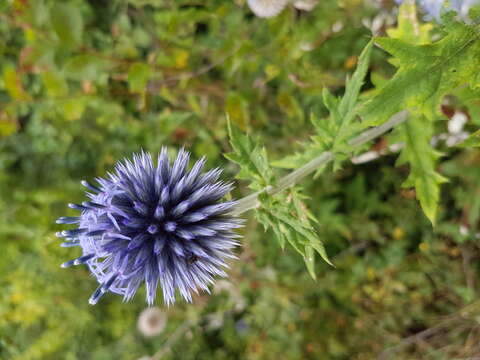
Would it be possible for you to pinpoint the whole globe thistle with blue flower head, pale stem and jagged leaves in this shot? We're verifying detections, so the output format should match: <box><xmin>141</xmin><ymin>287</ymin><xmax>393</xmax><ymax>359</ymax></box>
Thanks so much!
<box><xmin>53</xmin><ymin>1</ymin><xmax>480</xmax><ymax>305</ymax></box>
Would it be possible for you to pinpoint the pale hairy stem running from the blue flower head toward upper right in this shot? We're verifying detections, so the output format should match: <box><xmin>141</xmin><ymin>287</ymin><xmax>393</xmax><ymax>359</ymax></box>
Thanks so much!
<box><xmin>232</xmin><ymin>110</ymin><xmax>408</xmax><ymax>215</ymax></box>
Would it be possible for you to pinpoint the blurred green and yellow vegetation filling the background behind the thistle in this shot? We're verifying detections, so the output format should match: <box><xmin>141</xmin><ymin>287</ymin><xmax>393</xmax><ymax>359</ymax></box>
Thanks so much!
<box><xmin>0</xmin><ymin>0</ymin><xmax>480</xmax><ymax>360</ymax></box>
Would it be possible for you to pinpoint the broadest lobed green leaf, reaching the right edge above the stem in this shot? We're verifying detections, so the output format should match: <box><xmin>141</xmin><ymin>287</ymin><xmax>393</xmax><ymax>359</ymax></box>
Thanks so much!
<box><xmin>360</xmin><ymin>21</ymin><xmax>480</xmax><ymax>125</ymax></box>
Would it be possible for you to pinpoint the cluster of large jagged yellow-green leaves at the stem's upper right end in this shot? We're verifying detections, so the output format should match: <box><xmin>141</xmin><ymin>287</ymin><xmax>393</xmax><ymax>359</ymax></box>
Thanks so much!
<box><xmin>372</xmin><ymin>1</ymin><xmax>472</xmax><ymax>224</ymax></box>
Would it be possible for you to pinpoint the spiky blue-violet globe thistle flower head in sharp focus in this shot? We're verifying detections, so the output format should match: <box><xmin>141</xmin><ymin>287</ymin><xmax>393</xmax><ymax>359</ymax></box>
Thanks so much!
<box><xmin>57</xmin><ymin>148</ymin><xmax>241</xmax><ymax>305</ymax></box>
